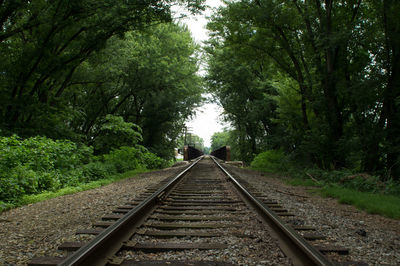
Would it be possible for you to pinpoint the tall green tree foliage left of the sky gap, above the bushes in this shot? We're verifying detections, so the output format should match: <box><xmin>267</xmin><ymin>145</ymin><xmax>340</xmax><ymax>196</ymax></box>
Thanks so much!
<box><xmin>0</xmin><ymin>0</ymin><xmax>204</xmax><ymax>159</ymax></box>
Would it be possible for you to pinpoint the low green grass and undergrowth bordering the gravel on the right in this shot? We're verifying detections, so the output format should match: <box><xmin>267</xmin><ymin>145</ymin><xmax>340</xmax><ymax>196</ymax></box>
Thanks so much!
<box><xmin>251</xmin><ymin>151</ymin><xmax>400</xmax><ymax>219</ymax></box>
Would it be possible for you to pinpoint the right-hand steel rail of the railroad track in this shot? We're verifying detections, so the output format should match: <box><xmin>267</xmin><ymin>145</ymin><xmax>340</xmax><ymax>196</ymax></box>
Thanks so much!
<box><xmin>211</xmin><ymin>156</ymin><xmax>333</xmax><ymax>266</ymax></box>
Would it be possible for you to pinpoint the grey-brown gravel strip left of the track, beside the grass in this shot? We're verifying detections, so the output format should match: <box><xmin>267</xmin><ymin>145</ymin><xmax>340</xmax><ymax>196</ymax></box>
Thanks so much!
<box><xmin>0</xmin><ymin>166</ymin><xmax>185</xmax><ymax>265</ymax></box>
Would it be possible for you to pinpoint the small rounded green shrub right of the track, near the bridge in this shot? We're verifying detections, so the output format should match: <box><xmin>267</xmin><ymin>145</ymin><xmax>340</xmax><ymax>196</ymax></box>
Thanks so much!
<box><xmin>250</xmin><ymin>150</ymin><xmax>286</xmax><ymax>172</ymax></box>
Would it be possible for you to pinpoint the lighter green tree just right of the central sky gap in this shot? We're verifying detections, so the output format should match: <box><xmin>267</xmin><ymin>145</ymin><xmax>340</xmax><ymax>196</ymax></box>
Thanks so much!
<box><xmin>206</xmin><ymin>13</ymin><xmax>276</xmax><ymax>162</ymax></box>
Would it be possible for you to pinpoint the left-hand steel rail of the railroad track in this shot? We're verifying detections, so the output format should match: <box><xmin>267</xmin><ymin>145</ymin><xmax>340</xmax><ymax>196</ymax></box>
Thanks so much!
<box><xmin>57</xmin><ymin>156</ymin><xmax>203</xmax><ymax>266</ymax></box>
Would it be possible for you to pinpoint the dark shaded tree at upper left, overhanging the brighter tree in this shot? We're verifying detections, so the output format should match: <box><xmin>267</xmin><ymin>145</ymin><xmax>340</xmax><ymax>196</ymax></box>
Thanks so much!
<box><xmin>0</xmin><ymin>0</ymin><xmax>203</xmax><ymax>137</ymax></box>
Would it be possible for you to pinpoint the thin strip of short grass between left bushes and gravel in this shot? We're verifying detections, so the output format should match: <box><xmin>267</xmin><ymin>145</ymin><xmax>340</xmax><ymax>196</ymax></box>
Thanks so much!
<box><xmin>0</xmin><ymin>168</ymin><xmax>150</xmax><ymax>213</ymax></box>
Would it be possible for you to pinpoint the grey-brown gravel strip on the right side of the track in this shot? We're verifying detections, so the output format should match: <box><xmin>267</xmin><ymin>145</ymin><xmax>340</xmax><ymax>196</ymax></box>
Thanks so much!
<box><xmin>225</xmin><ymin>165</ymin><xmax>400</xmax><ymax>265</ymax></box>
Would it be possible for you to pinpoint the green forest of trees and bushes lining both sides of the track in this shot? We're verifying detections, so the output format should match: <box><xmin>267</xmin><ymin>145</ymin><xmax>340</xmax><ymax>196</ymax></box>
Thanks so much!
<box><xmin>0</xmin><ymin>0</ymin><xmax>400</xmax><ymax>216</ymax></box>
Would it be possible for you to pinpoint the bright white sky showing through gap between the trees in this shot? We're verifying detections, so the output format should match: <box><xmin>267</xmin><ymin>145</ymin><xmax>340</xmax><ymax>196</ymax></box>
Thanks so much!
<box><xmin>173</xmin><ymin>0</ymin><xmax>226</xmax><ymax>147</ymax></box>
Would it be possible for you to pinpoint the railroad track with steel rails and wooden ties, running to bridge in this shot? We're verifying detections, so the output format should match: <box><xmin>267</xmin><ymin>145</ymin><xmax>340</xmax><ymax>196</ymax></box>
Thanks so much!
<box><xmin>28</xmin><ymin>157</ymin><xmax>356</xmax><ymax>266</ymax></box>
